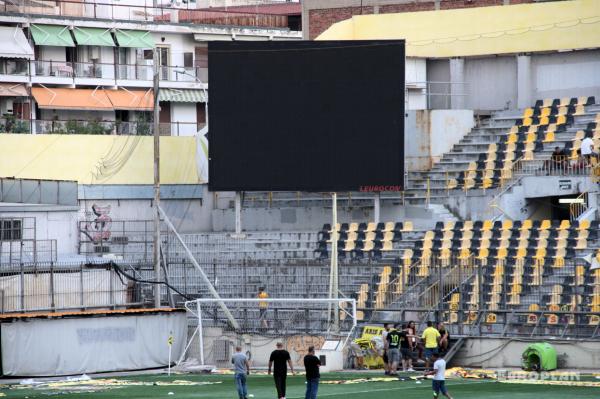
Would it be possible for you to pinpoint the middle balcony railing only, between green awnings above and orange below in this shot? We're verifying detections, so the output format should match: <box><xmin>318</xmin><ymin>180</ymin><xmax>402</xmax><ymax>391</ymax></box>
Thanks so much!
<box><xmin>0</xmin><ymin>60</ymin><xmax>208</xmax><ymax>83</ymax></box>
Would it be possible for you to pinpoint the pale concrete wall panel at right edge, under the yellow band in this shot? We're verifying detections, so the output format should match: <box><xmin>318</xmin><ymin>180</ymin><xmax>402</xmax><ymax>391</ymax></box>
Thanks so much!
<box><xmin>531</xmin><ymin>50</ymin><xmax>600</xmax><ymax>99</ymax></box>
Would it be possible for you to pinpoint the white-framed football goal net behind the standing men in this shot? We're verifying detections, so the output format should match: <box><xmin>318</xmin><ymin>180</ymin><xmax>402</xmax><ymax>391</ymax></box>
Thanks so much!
<box><xmin>180</xmin><ymin>298</ymin><xmax>356</xmax><ymax>368</ymax></box>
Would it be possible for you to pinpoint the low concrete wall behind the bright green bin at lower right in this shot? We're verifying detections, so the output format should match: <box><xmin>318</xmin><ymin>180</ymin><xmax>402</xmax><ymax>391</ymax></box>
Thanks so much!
<box><xmin>451</xmin><ymin>338</ymin><xmax>600</xmax><ymax>370</ymax></box>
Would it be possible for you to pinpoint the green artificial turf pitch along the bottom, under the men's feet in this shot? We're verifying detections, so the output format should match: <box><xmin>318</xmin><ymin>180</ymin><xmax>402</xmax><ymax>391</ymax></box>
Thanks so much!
<box><xmin>0</xmin><ymin>373</ymin><xmax>600</xmax><ymax>399</ymax></box>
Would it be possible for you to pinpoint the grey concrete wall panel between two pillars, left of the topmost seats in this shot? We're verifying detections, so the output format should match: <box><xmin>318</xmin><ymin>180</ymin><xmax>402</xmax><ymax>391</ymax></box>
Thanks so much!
<box><xmin>465</xmin><ymin>56</ymin><xmax>517</xmax><ymax>110</ymax></box>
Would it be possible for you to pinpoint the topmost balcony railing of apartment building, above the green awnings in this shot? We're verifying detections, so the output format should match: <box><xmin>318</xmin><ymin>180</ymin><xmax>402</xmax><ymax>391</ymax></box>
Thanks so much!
<box><xmin>0</xmin><ymin>0</ymin><xmax>296</xmax><ymax>28</ymax></box>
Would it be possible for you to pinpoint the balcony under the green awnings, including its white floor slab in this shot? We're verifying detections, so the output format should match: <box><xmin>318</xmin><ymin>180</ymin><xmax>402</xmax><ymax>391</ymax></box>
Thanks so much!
<box><xmin>0</xmin><ymin>59</ymin><xmax>208</xmax><ymax>89</ymax></box>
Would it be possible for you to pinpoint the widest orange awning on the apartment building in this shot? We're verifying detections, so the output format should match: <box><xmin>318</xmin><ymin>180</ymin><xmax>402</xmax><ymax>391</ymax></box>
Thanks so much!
<box><xmin>31</xmin><ymin>87</ymin><xmax>114</xmax><ymax>111</ymax></box>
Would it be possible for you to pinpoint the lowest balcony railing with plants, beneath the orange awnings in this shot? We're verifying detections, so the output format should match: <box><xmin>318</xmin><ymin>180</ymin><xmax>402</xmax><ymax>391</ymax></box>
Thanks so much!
<box><xmin>0</xmin><ymin>118</ymin><xmax>204</xmax><ymax>136</ymax></box>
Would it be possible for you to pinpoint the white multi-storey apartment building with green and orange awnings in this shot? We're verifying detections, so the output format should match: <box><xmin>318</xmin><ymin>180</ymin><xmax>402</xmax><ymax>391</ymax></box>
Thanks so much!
<box><xmin>0</xmin><ymin>0</ymin><xmax>301</xmax><ymax>136</ymax></box>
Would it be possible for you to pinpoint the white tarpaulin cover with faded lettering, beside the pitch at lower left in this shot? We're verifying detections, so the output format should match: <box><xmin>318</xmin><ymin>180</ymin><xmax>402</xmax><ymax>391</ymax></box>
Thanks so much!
<box><xmin>1</xmin><ymin>312</ymin><xmax>187</xmax><ymax>376</ymax></box>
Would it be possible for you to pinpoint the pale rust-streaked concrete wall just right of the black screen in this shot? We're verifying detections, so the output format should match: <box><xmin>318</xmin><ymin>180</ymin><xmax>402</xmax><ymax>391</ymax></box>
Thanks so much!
<box><xmin>404</xmin><ymin>110</ymin><xmax>475</xmax><ymax>170</ymax></box>
